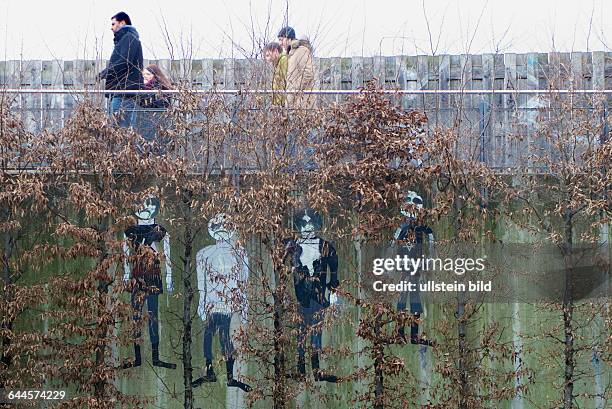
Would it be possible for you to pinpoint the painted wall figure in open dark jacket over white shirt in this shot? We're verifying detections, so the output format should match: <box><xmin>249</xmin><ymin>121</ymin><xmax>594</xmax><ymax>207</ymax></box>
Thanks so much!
<box><xmin>285</xmin><ymin>209</ymin><xmax>339</xmax><ymax>382</ymax></box>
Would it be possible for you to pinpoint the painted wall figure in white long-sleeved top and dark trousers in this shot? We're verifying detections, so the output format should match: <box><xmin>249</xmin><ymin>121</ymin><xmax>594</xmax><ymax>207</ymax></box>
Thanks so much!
<box><xmin>192</xmin><ymin>213</ymin><xmax>251</xmax><ymax>392</ymax></box>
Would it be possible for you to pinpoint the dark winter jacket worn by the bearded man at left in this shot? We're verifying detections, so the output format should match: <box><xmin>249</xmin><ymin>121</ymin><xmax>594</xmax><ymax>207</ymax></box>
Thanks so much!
<box><xmin>98</xmin><ymin>26</ymin><xmax>144</xmax><ymax>97</ymax></box>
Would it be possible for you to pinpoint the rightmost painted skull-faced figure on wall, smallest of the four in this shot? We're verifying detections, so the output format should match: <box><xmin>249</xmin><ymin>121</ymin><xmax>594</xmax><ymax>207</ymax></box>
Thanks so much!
<box><xmin>394</xmin><ymin>190</ymin><xmax>434</xmax><ymax>346</ymax></box>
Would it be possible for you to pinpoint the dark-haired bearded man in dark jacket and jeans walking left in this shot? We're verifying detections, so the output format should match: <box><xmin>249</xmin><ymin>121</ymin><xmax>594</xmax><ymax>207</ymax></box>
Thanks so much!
<box><xmin>98</xmin><ymin>11</ymin><xmax>144</xmax><ymax>127</ymax></box>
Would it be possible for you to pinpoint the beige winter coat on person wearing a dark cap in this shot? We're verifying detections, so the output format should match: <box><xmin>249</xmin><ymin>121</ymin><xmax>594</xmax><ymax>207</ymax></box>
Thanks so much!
<box><xmin>287</xmin><ymin>40</ymin><xmax>316</xmax><ymax>109</ymax></box>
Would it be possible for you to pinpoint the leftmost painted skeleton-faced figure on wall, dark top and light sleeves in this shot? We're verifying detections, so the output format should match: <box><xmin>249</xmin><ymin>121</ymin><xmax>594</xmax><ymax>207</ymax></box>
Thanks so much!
<box><xmin>123</xmin><ymin>197</ymin><xmax>176</xmax><ymax>369</ymax></box>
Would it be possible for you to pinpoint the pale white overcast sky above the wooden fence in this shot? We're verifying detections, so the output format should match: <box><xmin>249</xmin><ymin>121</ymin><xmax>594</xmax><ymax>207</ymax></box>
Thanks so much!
<box><xmin>0</xmin><ymin>0</ymin><xmax>612</xmax><ymax>60</ymax></box>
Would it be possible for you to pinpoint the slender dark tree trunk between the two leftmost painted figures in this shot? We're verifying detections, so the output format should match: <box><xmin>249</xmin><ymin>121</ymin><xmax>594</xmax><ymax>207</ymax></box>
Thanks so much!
<box><xmin>182</xmin><ymin>192</ymin><xmax>194</xmax><ymax>409</ymax></box>
